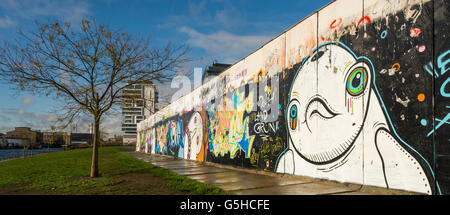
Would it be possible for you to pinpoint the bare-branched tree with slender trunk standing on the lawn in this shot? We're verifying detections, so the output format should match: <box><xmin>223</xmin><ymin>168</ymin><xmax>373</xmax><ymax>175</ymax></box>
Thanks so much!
<box><xmin>0</xmin><ymin>19</ymin><xmax>188</xmax><ymax>177</ymax></box>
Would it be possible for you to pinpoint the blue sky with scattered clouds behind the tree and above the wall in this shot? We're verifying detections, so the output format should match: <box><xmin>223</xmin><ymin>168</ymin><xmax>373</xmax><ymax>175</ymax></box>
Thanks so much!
<box><xmin>0</xmin><ymin>0</ymin><xmax>329</xmax><ymax>134</ymax></box>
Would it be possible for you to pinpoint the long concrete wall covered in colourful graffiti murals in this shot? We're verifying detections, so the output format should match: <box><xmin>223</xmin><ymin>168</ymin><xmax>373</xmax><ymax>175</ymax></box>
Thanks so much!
<box><xmin>136</xmin><ymin>0</ymin><xmax>450</xmax><ymax>194</ymax></box>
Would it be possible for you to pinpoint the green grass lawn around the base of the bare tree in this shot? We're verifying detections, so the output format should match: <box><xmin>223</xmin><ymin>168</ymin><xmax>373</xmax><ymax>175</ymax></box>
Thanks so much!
<box><xmin>0</xmin><ymin>147</ymin><xmax>227</xmax><ymax>195</ymax></box>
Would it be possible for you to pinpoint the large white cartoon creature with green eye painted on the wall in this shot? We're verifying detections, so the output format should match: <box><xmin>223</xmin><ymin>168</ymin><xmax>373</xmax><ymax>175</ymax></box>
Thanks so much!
<box><xmin>276</xmin><ymin>42</ymin><xmax>431</xmax><ymax>194</ymax></box>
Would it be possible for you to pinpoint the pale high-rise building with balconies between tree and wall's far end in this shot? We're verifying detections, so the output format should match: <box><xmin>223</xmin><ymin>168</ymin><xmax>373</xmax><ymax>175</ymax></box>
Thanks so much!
<box><xmin>122</xmin><ymin>83</ymin><xmax>158</xmax><ymax>144</ymax></box>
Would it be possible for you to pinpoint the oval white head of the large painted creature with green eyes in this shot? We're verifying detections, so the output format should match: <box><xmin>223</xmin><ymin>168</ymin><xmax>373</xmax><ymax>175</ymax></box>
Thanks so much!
<box><xmin>286</xmin><ymin>43</ymin><xmax>372</xmax><ymax>164</ymax></box>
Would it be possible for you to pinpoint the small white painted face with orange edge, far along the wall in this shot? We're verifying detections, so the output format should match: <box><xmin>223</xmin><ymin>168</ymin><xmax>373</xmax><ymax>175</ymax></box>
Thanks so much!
<box><xmin>184</xmin><ymin>112</ymin><xmax>203</xmax><ymax>160</ymax></box>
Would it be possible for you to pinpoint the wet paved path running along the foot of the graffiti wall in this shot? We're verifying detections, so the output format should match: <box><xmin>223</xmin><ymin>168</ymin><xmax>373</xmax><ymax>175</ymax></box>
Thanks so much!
<box><xmin>126</xmin><ymin>152</ymin><xmax>396</xmax><ymax>195</ymax></box>
